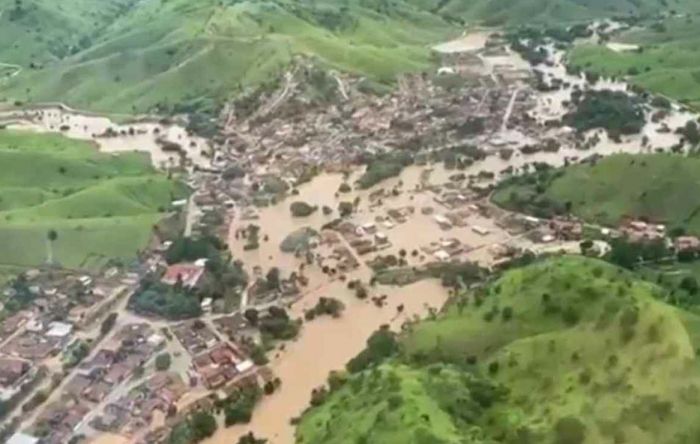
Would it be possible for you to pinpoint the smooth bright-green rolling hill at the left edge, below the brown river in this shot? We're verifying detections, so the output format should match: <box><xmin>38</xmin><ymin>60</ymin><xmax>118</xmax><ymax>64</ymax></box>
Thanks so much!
<box><xmin>0</xmin><ymin>131</ymin><xmax>185</xmax><ymax>268</ymax></box>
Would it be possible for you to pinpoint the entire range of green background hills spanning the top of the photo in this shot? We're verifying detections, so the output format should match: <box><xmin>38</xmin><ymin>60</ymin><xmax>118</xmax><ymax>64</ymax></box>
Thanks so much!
<box><xmin>0</xmin><ymin>0</ymin><xmax>693</xmax><ymax>113</ymax></box>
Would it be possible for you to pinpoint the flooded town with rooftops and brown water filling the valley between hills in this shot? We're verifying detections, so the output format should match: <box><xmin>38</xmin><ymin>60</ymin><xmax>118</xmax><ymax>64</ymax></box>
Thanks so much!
<box><xmin>0</xmin><ymin>21</ymin><xmax>700</xmax><ymax>444</ymax></box>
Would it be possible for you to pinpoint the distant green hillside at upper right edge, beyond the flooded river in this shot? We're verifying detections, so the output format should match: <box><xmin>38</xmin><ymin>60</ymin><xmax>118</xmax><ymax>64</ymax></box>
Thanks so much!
<box><xmin>570</xmin><ymin>17</ymin><xmax>700</xmax><ymax>108</ymax></box>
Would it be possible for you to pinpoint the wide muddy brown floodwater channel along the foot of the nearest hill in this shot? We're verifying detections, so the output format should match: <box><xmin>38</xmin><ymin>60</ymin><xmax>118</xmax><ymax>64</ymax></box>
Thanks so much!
<box><xmin>204</xmin><ymin>281</ymin><xmax>447</xmax><ymax>444</ymax></box>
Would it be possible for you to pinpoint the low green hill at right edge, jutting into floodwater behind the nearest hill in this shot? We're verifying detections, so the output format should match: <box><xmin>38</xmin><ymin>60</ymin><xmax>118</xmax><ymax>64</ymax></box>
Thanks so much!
<box><xmin>493</xmin><ymin>154</ymin><xmax>700</xmax><ymax>234</ymax></box>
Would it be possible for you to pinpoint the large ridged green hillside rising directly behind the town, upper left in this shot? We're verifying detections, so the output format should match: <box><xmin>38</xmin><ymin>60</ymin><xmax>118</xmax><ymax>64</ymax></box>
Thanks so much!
<box><xmin>0</xmin><ymin>0</ymin><xmax>457</xmax><ymax>112</ymax></box>
